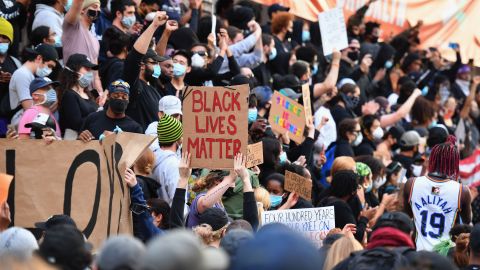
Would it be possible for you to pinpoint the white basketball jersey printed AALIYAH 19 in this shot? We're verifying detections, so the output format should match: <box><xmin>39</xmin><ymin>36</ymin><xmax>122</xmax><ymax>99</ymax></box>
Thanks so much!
<box><xmin>408</xmin><ymin>176</ymin><xmax>462</xmax><ymax>251</ymax></box>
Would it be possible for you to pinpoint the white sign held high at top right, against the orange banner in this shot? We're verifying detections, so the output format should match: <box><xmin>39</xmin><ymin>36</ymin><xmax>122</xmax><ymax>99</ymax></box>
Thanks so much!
<box><xmin>318</xmin><ymin>7</ymin><xmax>348</xmax><ymax>55</ymax></box>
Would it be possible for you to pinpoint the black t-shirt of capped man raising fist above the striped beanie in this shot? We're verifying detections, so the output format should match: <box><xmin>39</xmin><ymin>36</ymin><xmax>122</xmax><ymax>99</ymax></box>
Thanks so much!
<box><xmin>123</xmin><ymin>49</ymin><xmax>162</xmax><ymax>129</ymax></box>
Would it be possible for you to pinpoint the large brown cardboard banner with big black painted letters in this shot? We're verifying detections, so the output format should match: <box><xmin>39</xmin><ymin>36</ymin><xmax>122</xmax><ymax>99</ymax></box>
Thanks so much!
<box><xmin>0</xmin><ymin>132</ymin><xmax>155</xmax><ymax>248</ymax></box>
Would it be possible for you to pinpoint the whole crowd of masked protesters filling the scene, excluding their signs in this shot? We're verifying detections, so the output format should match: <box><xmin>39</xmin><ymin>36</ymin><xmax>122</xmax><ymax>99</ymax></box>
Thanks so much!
<box><xmin>0</xmin><ymin>0</ymin><xmax>480</xmax><ymax>270</ymax></box>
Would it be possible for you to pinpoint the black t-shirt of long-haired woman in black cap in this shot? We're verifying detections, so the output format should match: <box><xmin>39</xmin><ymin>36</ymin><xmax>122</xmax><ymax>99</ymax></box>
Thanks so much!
<box><xmin>59</xmin><ymin>89</ymin><xmax>98</xmax><ymax>133</ymax></box>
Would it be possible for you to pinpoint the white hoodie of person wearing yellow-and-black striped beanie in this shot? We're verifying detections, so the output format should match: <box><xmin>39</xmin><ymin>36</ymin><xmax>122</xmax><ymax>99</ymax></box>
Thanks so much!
<box><xmin>152</xmin><ymin>148</ymin><xmax>180</xmax><ymax>205</ymax></box>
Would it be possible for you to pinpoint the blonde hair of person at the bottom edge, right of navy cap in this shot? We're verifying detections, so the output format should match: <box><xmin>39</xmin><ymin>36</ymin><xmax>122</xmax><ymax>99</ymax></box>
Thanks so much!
<box><xmin>323</xmin><ymin>236</ymin><xmax>363</xmax><ymax>270</ymax></box>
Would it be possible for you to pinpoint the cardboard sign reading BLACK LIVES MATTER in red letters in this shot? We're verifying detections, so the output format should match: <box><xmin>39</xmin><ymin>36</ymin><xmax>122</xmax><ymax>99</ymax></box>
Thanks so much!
<box><xmin>183</xmin><ymin>85</ymin><xmax>249</xmax><ymax>169</ymax></box>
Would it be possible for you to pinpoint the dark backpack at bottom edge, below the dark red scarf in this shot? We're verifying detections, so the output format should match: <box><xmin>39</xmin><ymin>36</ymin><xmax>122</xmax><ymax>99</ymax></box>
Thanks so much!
<box><xmin>347</xmin><ymin>247</ymin><xmax>413</xmax><ymax>270</ymax></box>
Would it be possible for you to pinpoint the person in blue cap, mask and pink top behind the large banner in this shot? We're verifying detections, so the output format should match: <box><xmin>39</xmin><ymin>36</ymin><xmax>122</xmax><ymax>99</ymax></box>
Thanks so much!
<box><xmin>18</xmin><ymin>78</ymin><xmax>61</xmax><ymax>139</ymax></box>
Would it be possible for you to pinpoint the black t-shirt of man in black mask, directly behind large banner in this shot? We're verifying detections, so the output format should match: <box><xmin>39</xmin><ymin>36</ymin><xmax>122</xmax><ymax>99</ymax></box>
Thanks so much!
<box><xmin>82</xmin><ymin>111</ymin><xmax>143</xmax><ymax>140</ymax></box>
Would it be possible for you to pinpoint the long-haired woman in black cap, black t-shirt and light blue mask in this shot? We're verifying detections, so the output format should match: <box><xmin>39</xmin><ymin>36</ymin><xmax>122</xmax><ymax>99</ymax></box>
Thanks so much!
<box><xmin>58</xmin><ymin>54</ymin><xmax>98</xmax><ymax>137</ymax></box>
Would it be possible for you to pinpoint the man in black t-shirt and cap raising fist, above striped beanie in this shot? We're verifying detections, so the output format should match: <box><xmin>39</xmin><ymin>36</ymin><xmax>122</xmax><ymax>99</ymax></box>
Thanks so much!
<box><xmin>122</xmin><ymin>12</ymin><xmax>167</xmax><ymax>129</ymax></box>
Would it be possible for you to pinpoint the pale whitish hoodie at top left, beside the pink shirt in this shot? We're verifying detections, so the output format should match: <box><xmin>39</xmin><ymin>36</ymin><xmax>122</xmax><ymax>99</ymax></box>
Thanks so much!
<box><xmin>32</xmin><ymin>4</ymin><xmax>64</xmax><ymax>37</ymax></box>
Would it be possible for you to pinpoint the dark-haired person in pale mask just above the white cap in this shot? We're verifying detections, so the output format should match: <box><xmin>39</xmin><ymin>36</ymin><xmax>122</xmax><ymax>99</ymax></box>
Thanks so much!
<box><xmin>165</xmin><ymin>50</ymin><xmax>192</xmax><ymax>99</ymax></box>
